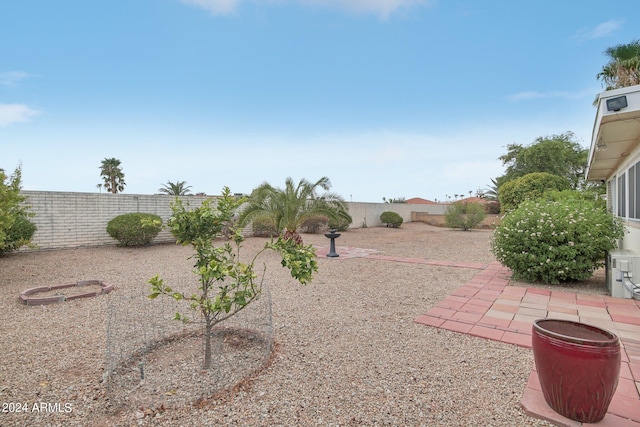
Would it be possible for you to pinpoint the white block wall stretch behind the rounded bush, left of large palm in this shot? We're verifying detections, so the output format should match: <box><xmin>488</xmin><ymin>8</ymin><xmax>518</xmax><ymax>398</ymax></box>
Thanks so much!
<box><xmin>22</xmin><ymin>191</ymin><xmax>209</xmax><ymax>249</ymax></box>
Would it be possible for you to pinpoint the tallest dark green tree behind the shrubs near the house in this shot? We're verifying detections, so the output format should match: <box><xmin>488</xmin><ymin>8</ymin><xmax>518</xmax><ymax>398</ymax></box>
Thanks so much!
<box><xmin>496</xmin><ymin>132</ymin><xmax>589</xmax><ymax>191</ymax></box>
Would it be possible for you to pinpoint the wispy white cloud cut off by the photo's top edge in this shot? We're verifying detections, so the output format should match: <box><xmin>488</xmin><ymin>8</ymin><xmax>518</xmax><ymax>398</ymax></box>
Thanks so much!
<box><xmin>181</xmin><ymin>0</ymin><xmax>433</xmax><ymax>18</ymax></box>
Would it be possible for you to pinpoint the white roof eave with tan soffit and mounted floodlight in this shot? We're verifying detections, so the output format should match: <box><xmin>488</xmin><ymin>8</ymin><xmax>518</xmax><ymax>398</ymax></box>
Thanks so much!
<box><xmin>586</xmin><ymin>85</ymin><xmax>640</xmax><ymax>181</ymax></box>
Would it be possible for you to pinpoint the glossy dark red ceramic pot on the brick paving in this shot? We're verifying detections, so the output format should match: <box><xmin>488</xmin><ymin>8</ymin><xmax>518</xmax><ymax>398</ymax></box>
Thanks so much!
<box><xmin>531</xmin><ymin>319</ymin><xmax>620</xmax><ymax>423</ymax></box>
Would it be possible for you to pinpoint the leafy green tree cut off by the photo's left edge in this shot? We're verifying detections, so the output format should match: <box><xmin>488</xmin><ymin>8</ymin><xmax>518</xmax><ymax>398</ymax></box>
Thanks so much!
<box><xmin>0</xmin><ymin>166</ymin><xmax>36</xmax><ymax>255</ymax></box>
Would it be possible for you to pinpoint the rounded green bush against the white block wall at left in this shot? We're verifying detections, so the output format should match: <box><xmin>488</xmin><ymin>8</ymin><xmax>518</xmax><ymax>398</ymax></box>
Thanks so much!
<box><xmin>107</xmin><ymin>212</ymin><xmax>162</xmax><ymax>246</ymax></box>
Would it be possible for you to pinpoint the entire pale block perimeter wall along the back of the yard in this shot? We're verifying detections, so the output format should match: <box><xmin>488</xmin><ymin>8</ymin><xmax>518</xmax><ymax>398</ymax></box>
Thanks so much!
<box><xmin>22</xmin><ymin>191</ymin><xmax>458</xmax><ymax>250</ymax></box>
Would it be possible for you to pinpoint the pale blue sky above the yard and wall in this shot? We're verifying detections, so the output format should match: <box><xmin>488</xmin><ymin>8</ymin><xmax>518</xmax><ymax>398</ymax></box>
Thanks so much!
<box><xmin>0</xmin><ymin>0</ymin><xmax>640</xmax><ymax>202</ymax></box>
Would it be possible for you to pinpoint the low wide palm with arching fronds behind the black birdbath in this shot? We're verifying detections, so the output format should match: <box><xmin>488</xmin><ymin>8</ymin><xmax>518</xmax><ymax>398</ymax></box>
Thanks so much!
<box><xmin>238</xmin><ymin>176</ymin><xmax>350</xmax><ymax>244</ymax></box>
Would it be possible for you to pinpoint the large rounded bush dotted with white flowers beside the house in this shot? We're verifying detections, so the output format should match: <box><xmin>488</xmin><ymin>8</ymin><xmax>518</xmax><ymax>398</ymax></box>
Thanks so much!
<box><xmin>491</xmin><ymin>197</ymin><xmax>624</xmax><ymax>284</ymax></box>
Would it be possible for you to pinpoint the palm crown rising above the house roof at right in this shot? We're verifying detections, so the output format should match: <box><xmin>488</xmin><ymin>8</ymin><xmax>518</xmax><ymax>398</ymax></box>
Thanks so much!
<box><xmin>597</xmin><ymin>40</ymin><xmax>640</xmax><ymax>90</ymax></box>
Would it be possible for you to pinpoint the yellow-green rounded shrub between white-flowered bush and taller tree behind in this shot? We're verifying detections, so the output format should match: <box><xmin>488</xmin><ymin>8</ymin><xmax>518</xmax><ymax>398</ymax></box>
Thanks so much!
<box><xmin>500</xmin><ymin>172</ymin><xmax>570</xmax><ymax>213</ymax></box>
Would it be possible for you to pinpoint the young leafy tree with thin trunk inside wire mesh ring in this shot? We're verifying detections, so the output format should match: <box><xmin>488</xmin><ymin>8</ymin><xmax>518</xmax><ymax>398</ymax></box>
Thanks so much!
<box><xmin>149</xmin><ymin>187</ymin><xmax>318</xmax><ymax>369</ymax></box>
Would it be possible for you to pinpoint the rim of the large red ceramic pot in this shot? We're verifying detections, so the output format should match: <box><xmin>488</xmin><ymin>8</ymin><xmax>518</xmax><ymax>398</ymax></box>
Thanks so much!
<box><xmin>533</xmin><ymin>319</ymin><xmax>619</xmax><ymax>347</ymax></box>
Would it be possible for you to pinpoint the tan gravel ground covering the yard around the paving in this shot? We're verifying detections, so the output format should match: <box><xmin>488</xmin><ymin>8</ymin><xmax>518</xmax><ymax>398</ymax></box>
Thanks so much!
<box><xmin>0</xmin><ymin>223</ymin><xmax>584</xmax><ymax>426</ymax></box>
